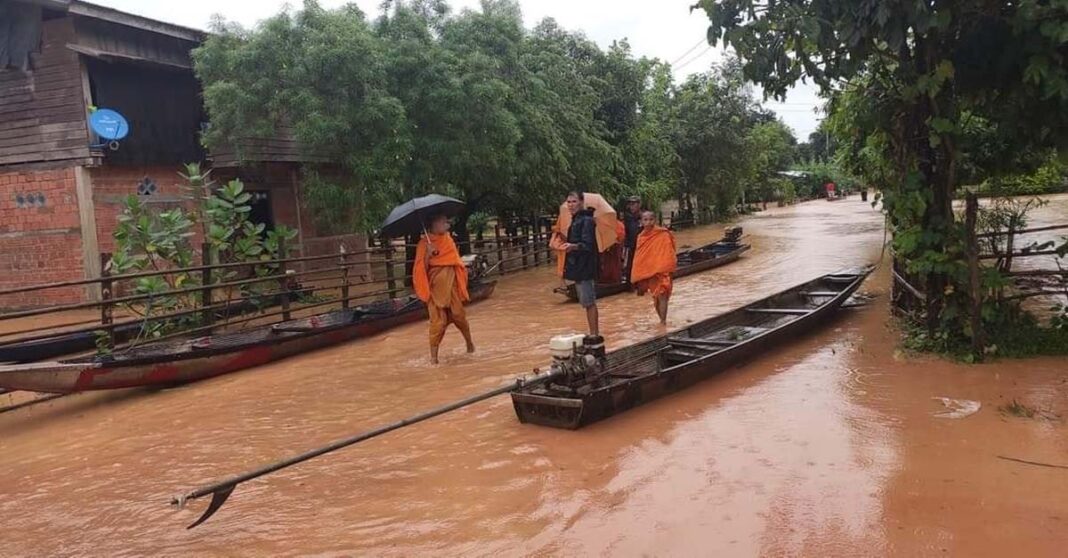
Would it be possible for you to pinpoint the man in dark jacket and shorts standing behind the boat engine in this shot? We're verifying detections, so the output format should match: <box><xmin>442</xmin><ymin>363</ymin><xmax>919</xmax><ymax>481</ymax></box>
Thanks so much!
<box><xmin>563</xmin><ymin>191</ymin><xmax>600</xmax><ymax>336</ymax></box>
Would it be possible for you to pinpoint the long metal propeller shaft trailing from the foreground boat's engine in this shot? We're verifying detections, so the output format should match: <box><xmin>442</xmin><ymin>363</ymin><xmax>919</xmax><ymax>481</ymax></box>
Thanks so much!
<box><xmin>171</xmin><ymin>372</ymin><xmax>562</xmax><ymax>529</ymax></box>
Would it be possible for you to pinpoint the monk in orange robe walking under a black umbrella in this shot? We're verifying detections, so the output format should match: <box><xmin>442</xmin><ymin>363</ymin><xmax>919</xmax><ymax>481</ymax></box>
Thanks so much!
<box><xmin>411</xmin><ymin>211</ymin><xmax>474</xmax><ymax>365</ymax></box>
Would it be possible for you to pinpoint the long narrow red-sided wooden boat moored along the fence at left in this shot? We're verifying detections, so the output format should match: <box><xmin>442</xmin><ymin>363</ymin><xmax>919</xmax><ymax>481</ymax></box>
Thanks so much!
<box><xmin>0</xmin><ymin>281</ymin><xmax>497</xmax><ymax>393</ymax></box>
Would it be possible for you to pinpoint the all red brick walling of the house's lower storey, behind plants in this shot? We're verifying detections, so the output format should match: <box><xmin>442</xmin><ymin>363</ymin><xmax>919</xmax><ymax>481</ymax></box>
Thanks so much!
<box><xmin>0</xmin><ymin>164</ymin><xmax>365</xmax><ymax>309</ymax></box>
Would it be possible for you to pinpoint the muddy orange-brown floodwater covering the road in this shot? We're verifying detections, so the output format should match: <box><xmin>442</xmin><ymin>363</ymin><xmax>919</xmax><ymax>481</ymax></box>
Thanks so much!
<box><xmin>0</xmin><ymin>197</ymin><xmax>1068</xmax><ymax>557</ymax></box>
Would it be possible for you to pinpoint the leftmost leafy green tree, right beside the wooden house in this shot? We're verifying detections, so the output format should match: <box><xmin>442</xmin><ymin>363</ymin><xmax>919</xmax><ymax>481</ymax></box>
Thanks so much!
<box><xmin>193</xmin><ymin>0</ymin><xmax>409</xmax><ymax>232</ymax></box>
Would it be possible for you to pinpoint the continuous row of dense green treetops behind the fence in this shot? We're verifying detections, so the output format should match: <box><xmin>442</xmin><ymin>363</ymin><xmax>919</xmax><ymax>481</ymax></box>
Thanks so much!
<box><xmin>187</xmin><ymin>0</ymin><xmax>794</xmax><ymax>239</ymax></box>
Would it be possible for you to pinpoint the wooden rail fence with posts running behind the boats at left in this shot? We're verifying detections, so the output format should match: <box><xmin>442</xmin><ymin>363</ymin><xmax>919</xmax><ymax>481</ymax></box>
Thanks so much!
<box><xmin>0</xmin><ymin>226</ymin><xmax>553</xmax><ymax>360</ymax></box>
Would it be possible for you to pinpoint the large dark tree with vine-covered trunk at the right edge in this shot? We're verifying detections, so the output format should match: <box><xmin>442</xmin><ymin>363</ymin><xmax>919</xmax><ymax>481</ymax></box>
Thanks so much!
<box><xmin>697</xmin><ymin>0</ymin><xmax>1068</xmax><ymax>332</ymax></box>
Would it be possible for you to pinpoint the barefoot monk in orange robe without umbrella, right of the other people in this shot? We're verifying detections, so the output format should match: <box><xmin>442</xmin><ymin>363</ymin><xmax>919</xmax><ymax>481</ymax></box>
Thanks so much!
<box><xmin>630</xmin><ymin>212</ymin><xmax>678</xmax><ymax>324</ymax></box>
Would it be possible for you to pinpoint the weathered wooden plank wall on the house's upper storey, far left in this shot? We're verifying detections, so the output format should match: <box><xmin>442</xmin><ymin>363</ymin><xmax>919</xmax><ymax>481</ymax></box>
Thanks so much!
<box><xmin>0</xmin><ymin>17</ymin><xmax>90</xmax><ymax>165</ymax></box>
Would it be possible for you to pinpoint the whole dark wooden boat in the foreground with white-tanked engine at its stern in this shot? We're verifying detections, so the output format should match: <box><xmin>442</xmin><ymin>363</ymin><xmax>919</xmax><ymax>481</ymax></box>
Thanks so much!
<box><xmin>512</xmin><ymin>268</ymin><xmax>870</xmax><ymax>430</ymax></box>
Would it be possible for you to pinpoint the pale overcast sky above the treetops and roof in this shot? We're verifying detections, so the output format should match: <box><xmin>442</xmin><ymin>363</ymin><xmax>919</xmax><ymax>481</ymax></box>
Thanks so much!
<box><xmin>92</xmin><ymin>0</ymin><xmax>820</xmax><ymax>137</ymax></box>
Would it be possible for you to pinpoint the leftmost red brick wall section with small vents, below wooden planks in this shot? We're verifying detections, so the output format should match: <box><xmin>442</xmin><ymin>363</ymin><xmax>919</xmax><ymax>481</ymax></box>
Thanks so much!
<box><xmin>0</xmin><ymin>168</ymin><xmax>85</xmax><ymax>309</ymax></box>
